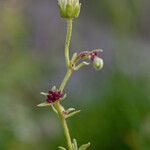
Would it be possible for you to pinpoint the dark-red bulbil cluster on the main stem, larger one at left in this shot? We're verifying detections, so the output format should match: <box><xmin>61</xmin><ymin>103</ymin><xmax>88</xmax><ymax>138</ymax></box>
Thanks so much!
<box><xmin>46</xmin><ymin>90</ymin><xmax>63</xmax><ymax>103</ymax></box>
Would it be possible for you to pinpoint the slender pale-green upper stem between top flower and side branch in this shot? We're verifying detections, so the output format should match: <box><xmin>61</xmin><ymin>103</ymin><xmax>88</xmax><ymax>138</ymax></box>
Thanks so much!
<box><xmin>65</xmin><ymin>19</ymin><xmax>72</xmax><ymax>67</ymax></box>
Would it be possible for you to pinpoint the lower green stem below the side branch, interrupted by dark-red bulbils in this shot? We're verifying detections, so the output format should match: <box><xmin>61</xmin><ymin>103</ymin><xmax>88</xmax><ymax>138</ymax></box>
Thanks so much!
<box><xmin>55</xmin><ymin>69</ymin><xmax>72</xmax><ymax>150</ymax></box>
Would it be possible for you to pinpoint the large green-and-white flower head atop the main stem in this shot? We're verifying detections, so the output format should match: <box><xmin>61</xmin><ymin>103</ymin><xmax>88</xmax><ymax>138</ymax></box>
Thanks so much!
<box><xmin>58</xmin><ymin>0</ymin><xmax>81</xmax><ymax>19</ymax></box>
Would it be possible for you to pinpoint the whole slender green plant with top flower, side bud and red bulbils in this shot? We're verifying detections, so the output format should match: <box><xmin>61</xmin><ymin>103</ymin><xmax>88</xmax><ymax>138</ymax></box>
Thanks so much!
<box><xmin>38</xmin><ymin>0</ymin><xmax>103</xmax><ymax>150</ymax></box>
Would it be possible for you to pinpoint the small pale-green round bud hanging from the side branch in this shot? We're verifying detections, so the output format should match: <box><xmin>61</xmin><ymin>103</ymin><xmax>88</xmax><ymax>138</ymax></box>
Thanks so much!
<box><xmin>93</xmin><ymin>56</ymin><xmax>104</xmax><ymax>70</ymax></box>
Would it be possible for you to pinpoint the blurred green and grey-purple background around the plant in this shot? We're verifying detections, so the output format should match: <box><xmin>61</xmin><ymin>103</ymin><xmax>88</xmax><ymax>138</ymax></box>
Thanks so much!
<box><xmin>0</xmin><ymin>0</ymin><xmax>150</xmax><ymax>150</ymax></box>
